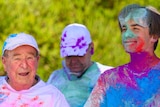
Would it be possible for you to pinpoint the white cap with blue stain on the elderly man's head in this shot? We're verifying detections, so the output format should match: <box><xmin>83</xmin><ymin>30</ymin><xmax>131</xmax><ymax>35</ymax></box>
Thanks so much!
<box><xmin>2</xmin><ymin>33</ymin><xmax>39</xmax><ymax>55</ymax></box>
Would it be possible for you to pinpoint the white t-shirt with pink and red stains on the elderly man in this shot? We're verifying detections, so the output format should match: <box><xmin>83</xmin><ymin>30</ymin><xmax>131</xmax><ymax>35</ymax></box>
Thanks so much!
<box><xmin>0</xmin><ymin>77</ymin><xmax>69</xmax><ymax>107</ymax></box>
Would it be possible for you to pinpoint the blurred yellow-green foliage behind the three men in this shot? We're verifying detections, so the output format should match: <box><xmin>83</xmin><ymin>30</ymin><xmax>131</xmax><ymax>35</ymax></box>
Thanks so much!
<box><xmin>0</xmin><ymin>0</ymin><xmax>160</xmax><ymax>81</ymax></box>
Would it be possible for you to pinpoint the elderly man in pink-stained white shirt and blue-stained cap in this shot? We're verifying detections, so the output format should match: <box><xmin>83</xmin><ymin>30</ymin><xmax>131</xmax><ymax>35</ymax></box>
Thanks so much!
<box><xmin>0</xmin><ymin>33</ymin><xmax>69</xmax><ymax>107</ymax></box>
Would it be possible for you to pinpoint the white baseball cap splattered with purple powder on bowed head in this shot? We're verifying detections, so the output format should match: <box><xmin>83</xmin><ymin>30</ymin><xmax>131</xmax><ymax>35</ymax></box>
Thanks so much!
<box><xmin>60</xmin><ymin>23</ymin><xmax>92</xmax><ymax>57</ymax></box>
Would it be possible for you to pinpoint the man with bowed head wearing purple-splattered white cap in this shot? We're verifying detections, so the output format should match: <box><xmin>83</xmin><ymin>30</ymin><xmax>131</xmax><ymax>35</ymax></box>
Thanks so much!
<box><xmin>48</xmin><ymin>23</ymin><xmax>112</xmax><ymax>107</ymax></box>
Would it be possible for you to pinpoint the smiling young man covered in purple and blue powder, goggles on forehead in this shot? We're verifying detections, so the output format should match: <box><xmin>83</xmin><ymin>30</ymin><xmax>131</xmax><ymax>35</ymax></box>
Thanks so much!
<box><xmin>84</xmin><ymin>4</ymin><xmax>160</xmax><ymax>107</ymax></box>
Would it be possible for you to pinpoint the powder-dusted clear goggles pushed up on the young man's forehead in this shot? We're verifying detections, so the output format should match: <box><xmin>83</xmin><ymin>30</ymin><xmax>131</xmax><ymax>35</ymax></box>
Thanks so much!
<box><xmin>119</xmin><ymin>8</ymin><xmax>149</xmax><ymax>27</ymax></box>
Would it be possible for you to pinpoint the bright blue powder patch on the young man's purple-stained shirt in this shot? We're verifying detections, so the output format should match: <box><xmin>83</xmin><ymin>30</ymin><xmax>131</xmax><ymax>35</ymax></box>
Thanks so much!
<box><xmin>100</xmin><ymin>70</ymin><xmax>160</xmax><ymax>107</ymax></box>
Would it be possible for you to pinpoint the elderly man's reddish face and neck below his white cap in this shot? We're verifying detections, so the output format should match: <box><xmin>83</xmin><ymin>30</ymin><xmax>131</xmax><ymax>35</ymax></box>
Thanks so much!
<box><xmin>2</xmin><ymin>45</ymin><xmax>39</xmax><ymax>90</ymax></box>
